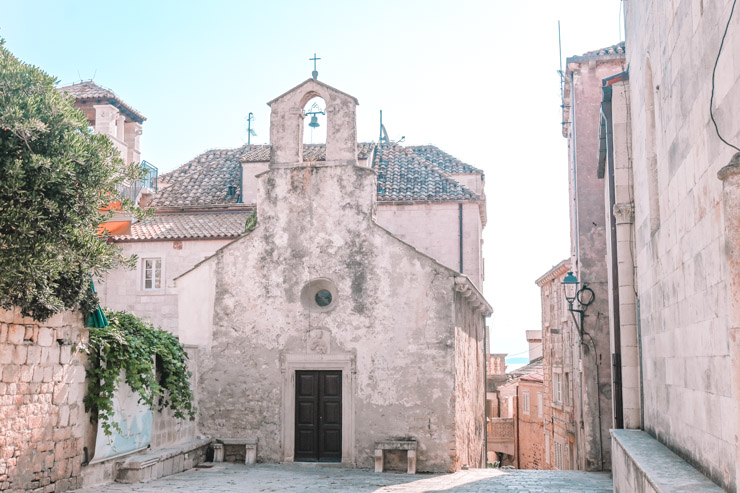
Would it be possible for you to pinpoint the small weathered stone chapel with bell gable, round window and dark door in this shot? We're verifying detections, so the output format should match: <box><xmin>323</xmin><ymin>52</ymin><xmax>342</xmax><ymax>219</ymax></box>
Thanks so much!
<box><xmin>176</xmin><ymin>79</ymin><xmax>491</xmax><ymax>471</ymax></box>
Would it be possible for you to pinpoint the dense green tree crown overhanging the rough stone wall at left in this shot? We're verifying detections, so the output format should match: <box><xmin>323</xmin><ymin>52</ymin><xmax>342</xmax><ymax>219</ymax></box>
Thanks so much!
<box><xmin>0</xmin><ymin>39</ymin><xmax>141</xmax><ymax>320</ymax></box>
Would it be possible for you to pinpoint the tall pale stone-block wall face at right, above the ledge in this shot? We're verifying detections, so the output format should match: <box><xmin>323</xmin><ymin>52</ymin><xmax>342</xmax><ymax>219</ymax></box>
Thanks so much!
<box><xmin>625</xmin><ymin>0</ymin><xmax>740</xmax><ymax>491</ymax></box>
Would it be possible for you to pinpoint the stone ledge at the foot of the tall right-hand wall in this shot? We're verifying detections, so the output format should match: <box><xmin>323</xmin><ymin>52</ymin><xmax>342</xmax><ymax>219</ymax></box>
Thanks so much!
<box><xmin>611</xmin><ymin>430</ymin><xmax>722</xmax><ymax>493</ymax></box>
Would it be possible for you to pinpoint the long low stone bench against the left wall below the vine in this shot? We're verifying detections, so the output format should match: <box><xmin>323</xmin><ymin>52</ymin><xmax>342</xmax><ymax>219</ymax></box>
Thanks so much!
<box><xmin>115</xmin><ymin>438</ymin><xmax>211</xmax><ymax>483</ymax></box>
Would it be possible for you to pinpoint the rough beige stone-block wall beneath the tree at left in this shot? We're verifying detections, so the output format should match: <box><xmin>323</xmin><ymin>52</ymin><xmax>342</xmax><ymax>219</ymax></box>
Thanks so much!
<box><xmin>0</xmin><ymin>310</ymin><xmax>87</xmax><ymax>492</ymax></box>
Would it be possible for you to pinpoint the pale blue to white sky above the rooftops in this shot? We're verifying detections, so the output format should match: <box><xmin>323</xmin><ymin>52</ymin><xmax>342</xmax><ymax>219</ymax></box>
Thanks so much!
<box><xmin>0</xmin><ymin>0</ymin><xmax>620</xmax><ymax>362</ymax></box>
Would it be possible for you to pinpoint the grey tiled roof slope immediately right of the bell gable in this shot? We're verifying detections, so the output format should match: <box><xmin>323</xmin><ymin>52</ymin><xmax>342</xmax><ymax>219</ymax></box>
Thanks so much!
<box><xmin>373</xmin><ymin>144</ymin><xmax>478</xmax><ymax>202</ymax></box>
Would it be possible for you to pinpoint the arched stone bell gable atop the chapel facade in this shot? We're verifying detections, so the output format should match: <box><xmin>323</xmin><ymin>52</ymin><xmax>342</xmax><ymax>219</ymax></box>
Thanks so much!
<box><xmin>267</xmin><ymin>79</ymin><xmax>359</xmax><ymax>168</ymax></box>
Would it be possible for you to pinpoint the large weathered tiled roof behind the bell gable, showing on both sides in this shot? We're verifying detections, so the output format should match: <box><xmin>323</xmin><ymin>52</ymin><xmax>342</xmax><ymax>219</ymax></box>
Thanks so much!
<box><xmin>151</xmin><ymin>142</ymin><xmax>480</xmax><ymax>208</ymax></box>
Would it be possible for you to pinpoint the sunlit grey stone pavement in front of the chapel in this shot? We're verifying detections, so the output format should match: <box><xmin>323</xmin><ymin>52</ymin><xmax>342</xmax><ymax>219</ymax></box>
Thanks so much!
<box><xmin>76</xmin><ymin>463</ymin><xmax>613</xmax><ymax>493</ymax></box>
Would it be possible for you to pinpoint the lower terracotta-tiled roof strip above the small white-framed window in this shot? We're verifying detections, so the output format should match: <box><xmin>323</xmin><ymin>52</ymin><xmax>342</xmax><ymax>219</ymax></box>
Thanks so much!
<box><xmin>112</xmin><ymin>209</ymin><xmax>252</xmax><ymax>241</ymax></box>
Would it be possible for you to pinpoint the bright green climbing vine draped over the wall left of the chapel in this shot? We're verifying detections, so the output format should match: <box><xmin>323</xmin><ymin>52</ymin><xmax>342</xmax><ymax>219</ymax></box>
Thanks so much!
<box><xmin>82</xmin><ymin>311</ymin><xmax>195</xmax><ymax>435</ymax></box>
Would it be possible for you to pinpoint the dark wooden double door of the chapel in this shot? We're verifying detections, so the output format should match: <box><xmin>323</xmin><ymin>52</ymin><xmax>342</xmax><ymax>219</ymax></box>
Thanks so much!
<box><xmin>295</xmin><ymin>370</ymin><xmax>342</xmax><ymax>462</ymax></box>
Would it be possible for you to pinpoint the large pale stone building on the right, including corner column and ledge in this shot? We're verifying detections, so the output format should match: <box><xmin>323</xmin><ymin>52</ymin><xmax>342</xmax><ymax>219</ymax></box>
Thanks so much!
<box><xmin>598</xmin><ymin>0</ymin><xmax>740</xmax><ymax>492</ymax></box>
